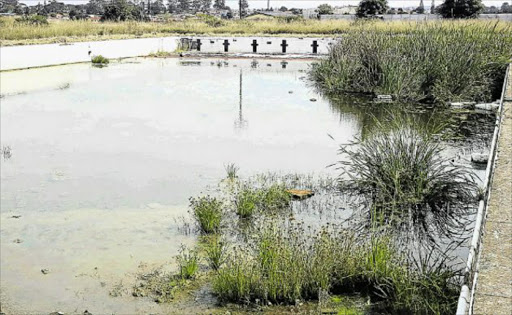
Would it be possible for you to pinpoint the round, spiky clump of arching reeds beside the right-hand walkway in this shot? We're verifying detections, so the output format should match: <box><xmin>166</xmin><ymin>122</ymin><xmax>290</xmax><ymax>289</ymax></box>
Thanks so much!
<box><xmin>339</xmin><ymin>124</ymin><xmax>478</xmax><ymax>241</ymax></box>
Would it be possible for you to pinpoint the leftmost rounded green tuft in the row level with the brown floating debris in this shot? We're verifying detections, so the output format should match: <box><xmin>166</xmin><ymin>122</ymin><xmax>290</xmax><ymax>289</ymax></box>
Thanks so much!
<box><xmin>190</xmin><ymin>196</ymin><xmax>223</xmax><ymax>234</ymax></box>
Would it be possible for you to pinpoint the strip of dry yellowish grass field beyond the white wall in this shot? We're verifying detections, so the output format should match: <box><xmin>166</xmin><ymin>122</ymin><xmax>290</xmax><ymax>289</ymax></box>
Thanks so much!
<box><xmin>0</xmin><ymin>17</ymin><xmax>510</xmax><ymax>46</ymax></box>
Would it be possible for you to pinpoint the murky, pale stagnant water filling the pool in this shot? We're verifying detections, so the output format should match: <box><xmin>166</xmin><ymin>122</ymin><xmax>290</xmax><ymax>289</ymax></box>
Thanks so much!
<box><xmin>0</xmin><ymin>59</ymin><xmax>494</xmax><ymax>314</ymax></box>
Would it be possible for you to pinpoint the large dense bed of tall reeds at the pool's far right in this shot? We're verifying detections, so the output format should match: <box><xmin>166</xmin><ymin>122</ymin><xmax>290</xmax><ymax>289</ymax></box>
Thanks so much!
<box><xmin>311</xmin><ymin>22</ymin><xmax>512</xmax><ymax>104</ymax></box>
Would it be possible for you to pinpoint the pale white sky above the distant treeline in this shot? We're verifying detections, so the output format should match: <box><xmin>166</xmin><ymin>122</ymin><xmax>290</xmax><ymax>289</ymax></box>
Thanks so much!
<box><xmin>20</xmin><ymin>0</ymin><xmax>512</xmax><ymax>9</ymax></box>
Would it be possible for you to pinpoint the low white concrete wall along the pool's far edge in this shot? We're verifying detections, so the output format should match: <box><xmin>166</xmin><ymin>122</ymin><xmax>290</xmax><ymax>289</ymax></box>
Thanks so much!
<box><xmin>0</xmin><ymin>37</ymin><xmax>335</xmax><ymax>70</ymax></box>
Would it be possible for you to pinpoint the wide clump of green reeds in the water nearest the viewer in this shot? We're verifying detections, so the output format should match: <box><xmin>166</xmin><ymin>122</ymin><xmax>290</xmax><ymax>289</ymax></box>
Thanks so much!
<box><xmin>213</xmin><ymin>226</ymin><xmax>458</xmax><ymax>314</ymax></box>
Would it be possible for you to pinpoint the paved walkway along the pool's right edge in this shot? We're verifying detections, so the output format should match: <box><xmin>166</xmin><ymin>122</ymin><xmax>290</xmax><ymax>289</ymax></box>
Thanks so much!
<box><xmin>473</xmin><ymin>71</ymin><xmax>512</xmax><ymax>315</ymax></box>
